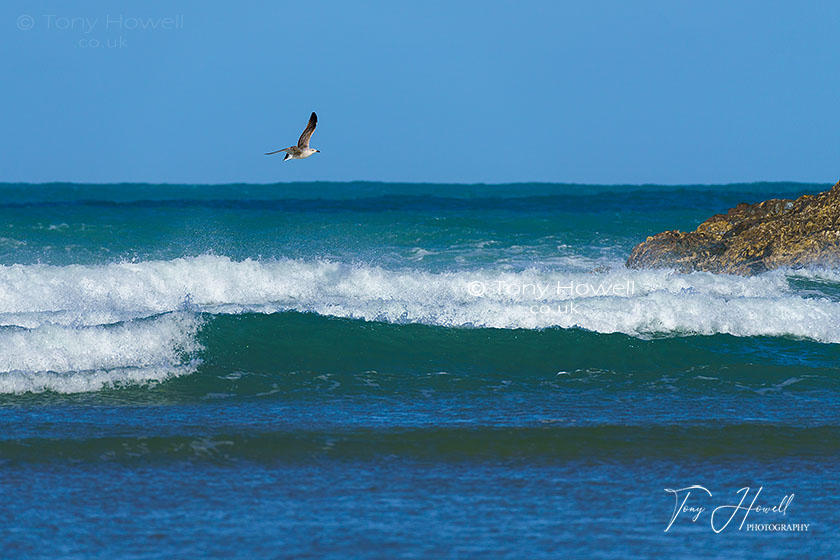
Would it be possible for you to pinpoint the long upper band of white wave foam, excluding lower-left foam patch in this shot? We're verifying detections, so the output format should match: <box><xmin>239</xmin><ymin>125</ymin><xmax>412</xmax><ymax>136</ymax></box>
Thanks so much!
<box><xmin>0</xmin><ymin>256</ymin><xmax>840</xmax><ymax>343</ymax></box>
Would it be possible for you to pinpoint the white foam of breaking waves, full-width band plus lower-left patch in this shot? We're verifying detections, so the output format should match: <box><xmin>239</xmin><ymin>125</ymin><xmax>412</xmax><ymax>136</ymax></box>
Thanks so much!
<box><xmin>0</xmin><ymin>255</ymin><xmax>840</xmax><ymax>391</ymax></box>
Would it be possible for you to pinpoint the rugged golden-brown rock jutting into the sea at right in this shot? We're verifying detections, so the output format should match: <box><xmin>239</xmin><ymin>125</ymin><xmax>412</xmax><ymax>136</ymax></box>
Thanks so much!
<box><xmin>627</xmin><ymin>182</ymin><xmax>840</xmax><ymax>275</ymax></box>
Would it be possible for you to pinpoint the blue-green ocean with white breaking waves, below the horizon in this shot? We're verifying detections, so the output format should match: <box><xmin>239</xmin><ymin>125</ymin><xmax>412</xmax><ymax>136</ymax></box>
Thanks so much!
<box><xmin>0</xmin><ymin>182</ymin><xmax>840</xmax><ymax>559</ymax></box>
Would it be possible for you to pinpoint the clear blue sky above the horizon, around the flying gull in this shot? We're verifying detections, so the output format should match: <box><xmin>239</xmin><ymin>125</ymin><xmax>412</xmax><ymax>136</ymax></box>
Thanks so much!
<box><xmin>0</xmin><ymin>0</ymin><xmax>840</xmax><ymax>184</ymax></box>
